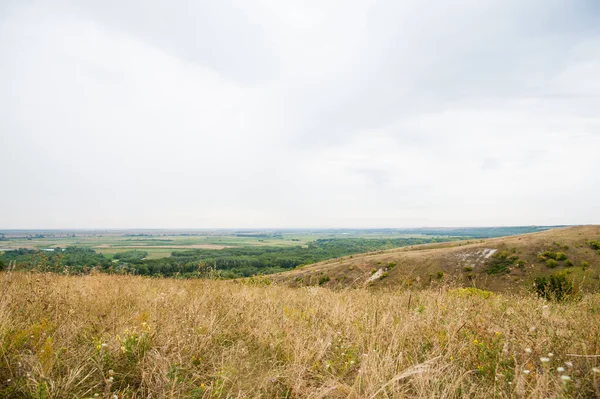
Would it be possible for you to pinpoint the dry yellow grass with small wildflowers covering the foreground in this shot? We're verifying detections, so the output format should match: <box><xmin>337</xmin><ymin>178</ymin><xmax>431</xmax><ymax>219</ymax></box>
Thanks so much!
<box><xmin>0</xmin><ymin>273</ymin><xmax>600</xmax><ymax>398</ymax></box>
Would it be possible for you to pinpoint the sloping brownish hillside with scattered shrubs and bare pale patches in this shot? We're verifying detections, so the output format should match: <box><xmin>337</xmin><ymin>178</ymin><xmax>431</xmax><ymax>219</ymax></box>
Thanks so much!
<box><xmin>272</xmin><ymin>226</ymin><xmax>600</xmax><ymax>291</ymax></box>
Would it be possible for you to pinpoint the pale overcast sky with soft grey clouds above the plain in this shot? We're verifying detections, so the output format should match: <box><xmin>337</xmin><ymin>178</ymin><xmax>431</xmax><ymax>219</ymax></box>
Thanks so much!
<box><xmin>0</xmin><ymin>0</ymin><xmax>600</xmax><ymax>229</ymax></box>
